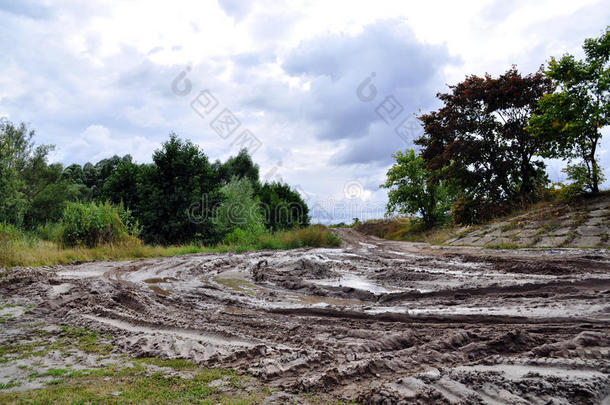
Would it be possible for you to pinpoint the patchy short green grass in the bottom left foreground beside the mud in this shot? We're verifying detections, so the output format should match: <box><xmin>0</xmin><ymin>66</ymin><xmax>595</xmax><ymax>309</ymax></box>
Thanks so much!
<box><xmin>0</xmin><ymin>334</ymin><xmax>339</xmax><ymax>404</ymax></box>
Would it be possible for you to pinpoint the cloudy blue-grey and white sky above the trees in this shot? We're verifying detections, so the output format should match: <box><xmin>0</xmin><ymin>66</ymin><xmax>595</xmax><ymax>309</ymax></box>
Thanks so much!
<box><xmin>0</xmin><ymin>0</ymin><xmax>610</xmax><ymax>223</ymax></box>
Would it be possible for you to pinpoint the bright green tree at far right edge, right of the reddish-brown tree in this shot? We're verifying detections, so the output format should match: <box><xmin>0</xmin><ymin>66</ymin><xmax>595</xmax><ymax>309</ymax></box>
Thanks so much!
<box><xmin>528</xmin><ymin>27</ymin><xmax>610</xmax><ymax>193</ymax></box>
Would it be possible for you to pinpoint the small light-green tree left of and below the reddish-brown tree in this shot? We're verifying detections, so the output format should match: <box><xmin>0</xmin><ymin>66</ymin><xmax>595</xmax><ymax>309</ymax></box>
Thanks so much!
<box><xmin>381</xmin><ymin>149</ymin><xmax>452</xmax><ymax>226</ymax></box>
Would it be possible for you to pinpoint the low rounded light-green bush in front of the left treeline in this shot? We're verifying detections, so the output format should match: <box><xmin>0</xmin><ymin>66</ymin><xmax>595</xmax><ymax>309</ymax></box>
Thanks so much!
<box><xmin>61</xmin><ymin>202</ymin><xmax>138</xmax><ymax>248</ymax></box>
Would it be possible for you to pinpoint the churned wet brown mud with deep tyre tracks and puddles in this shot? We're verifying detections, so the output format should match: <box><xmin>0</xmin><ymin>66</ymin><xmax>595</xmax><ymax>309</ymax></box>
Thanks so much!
<box><xmin>0</xmin><ymin>229</ymin><xmax>610</xmax><ymax>404</ymax></box>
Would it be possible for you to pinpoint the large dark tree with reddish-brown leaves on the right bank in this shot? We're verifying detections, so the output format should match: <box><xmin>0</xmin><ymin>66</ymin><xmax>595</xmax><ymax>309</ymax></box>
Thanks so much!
<box><xmin>415</xmin><ymin>67</ymin><xmax>553</xmax><ymax>221</ymax></box>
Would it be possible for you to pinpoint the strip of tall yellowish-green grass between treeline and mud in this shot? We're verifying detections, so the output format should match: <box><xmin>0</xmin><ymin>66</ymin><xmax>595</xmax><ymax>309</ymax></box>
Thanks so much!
<box><xmin>0</xmin><ymin>225</ymin><xmax>341</xmax><ymax>268</ymax></box>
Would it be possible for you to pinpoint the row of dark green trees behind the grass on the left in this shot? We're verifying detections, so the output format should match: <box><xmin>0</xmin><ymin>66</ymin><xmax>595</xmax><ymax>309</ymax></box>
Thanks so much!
<box><xmin>0</xmin><ymin>120</ymin><xmax>309</xmax><ymax>244</ymax></box>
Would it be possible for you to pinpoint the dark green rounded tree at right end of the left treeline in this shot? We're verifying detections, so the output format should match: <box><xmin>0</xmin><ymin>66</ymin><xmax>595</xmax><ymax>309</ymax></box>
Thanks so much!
<box><xmin>259</xmin><ymin>182</ymin><xmax>309</xmax><ymax>231</ymax></box>
